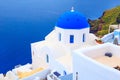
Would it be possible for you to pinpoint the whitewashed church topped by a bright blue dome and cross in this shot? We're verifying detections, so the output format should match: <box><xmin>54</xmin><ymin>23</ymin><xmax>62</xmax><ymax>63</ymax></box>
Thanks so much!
<box><xmin>31</xmin><ymin>9</ymin><xmax>96</xmax><ymax>80</ymax></box>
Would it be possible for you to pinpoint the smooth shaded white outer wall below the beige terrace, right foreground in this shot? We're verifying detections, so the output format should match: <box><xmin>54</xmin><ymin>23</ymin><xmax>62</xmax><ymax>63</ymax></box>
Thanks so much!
<box><xmin>73</xmin><ymin>44</ymin><xmax>120</xmax><ymax>80</ymax></box>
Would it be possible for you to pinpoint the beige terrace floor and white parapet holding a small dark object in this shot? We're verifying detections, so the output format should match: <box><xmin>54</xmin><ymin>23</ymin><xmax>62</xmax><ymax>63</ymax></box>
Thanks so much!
<box><xmin>76</xmin><ymin>43</ymin><xmax>120</xmax><ymax>71</ymax></box>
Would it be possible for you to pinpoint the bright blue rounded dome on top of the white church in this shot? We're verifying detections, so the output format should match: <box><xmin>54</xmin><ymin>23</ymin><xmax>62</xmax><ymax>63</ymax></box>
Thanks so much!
<box><xmin>56</xmin><ymin>11</ymin><xmax>89</xmax><ymax>29</ymax></box>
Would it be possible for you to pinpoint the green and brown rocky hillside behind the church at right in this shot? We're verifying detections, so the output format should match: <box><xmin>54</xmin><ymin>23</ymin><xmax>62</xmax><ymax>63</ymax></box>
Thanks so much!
<box><xmin>88</xmin><ymin>6</ymin><xmax>120</xmax><ymax>37</ymax></box>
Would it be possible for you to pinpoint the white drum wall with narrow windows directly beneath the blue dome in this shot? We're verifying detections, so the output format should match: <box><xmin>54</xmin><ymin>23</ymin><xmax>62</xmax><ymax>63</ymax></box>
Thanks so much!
<box><xmin>55</xmin><ymin>27</ymin><xmax>89</xmax><ymax>44</ymax></box>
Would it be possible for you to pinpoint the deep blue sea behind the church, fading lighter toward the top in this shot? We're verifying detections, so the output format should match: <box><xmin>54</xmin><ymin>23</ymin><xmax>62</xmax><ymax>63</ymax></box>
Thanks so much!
<box><xmin>0</xmin><ymin>0</ymin><xmax>120</xmax><ymax>73</ymax></box>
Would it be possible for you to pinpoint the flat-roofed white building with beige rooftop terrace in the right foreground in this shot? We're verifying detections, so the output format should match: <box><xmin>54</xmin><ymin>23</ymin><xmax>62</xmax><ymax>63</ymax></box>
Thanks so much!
<box><xmin>73</xmin><ymin>43</ymin><xmax>120</xmax><ymax>80</ymax></box>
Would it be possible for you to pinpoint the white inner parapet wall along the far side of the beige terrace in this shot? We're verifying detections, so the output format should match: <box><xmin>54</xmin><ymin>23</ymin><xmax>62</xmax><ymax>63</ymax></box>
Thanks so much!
<box><xmin>79</xmin><ymin>43</ymin><xmax>120</xmax><ymax>58</ymax></box>
